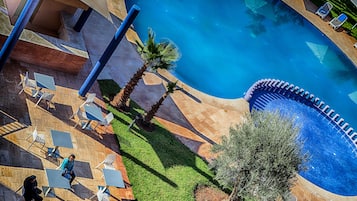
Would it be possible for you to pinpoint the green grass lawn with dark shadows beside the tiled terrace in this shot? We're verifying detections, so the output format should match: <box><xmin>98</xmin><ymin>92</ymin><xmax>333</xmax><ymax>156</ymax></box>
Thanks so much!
<box><xmin>99</xmin><ymin>80</ymin><xmax>217</xmax><ymax>201</ymax></box>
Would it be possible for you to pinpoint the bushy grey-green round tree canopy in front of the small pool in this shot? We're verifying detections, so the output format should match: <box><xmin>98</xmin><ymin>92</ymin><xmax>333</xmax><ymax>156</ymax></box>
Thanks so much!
<box><xmin>210</xmin><ymin>111</ymin><xmax>308</xmax><ymax>200</ymax></box>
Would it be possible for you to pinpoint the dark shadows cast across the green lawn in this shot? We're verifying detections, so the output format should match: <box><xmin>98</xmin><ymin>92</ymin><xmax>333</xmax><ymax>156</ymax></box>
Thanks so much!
<box><xmin>100</xmin><ymin>80</ymin><xmax>215</xmax><ymax>184</ymax></box>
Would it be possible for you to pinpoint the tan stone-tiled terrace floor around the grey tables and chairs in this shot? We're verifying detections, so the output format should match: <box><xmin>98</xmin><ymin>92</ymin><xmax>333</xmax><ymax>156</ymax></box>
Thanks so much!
<box><xmin>0</xmin><ymin>58</ymin><xmax>134</xmax><ymax>201</ymax></box>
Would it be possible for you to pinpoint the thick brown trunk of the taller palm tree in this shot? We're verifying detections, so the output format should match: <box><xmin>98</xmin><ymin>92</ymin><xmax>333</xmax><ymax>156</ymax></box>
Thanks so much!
<box><xmin>110</xmin><ymin>63</ymin><xmax>148</xmax><ymax>109</ymax></box>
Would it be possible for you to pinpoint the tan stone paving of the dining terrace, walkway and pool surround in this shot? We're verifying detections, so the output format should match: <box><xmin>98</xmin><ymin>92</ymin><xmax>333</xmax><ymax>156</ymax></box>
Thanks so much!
<box><xmin>0</xmin><ymin>0</ymin><xmax>357</xmax><ymax>201</ymax></box>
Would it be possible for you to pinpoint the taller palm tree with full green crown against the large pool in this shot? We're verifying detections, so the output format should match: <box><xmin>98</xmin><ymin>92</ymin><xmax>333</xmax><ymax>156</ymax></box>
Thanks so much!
<box><xmin>110</xmin><ymin>29</ymin><xmax>180</xmax><ymax>109</ymax></box>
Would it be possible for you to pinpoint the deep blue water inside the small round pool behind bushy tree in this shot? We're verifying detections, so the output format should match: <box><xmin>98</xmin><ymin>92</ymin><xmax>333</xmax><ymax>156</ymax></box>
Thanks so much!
<box><xmin>264</xmin><ymin>99</ymin><xmax>357</xmax><ymax>196</ymax></box>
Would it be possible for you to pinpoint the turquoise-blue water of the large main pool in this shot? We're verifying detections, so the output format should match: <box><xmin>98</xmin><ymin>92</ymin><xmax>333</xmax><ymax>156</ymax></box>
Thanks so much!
<box><xmin>126</xmin><ymin>0</ymin><xmax>357</xmax><ymax>195</ymax></box>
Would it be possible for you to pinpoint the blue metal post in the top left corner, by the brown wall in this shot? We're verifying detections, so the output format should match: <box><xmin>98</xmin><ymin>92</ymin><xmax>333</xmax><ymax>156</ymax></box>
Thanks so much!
<box><xmin>0</xmin><ymin>0</ymin><xmax>40</xmax><ymax>71</ymax></box>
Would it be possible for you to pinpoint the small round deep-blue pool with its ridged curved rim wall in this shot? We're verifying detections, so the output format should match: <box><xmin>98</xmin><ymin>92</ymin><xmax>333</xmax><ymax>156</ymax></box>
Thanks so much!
<box><xmin>244</xmin><ymin>79</ymin><xmax>357</xmax><ymax>196</ymax></box>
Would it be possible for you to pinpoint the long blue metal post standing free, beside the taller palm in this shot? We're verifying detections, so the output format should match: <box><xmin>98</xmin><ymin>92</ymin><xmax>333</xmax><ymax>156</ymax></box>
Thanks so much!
<box><xmin>78</xmin><ymin>5</ymin><xmax>140</xmax><ymax>97</ymax></box>
